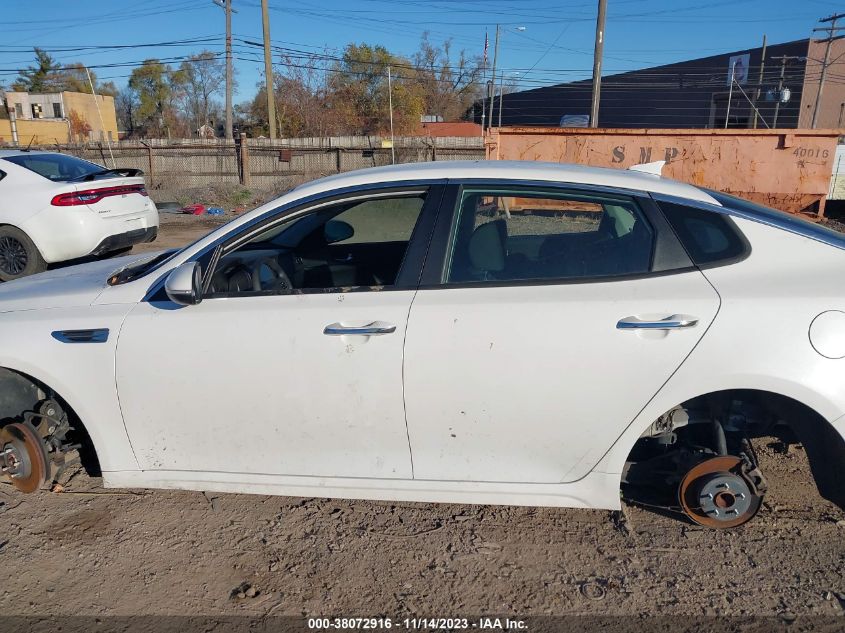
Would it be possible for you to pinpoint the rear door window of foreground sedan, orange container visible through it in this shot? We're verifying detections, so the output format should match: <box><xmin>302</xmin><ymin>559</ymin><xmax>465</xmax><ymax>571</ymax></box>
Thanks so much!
<box><xmin>446</xmin><ymin>189</ymin><xmax>654</xmax><ymax>283</ymax></box>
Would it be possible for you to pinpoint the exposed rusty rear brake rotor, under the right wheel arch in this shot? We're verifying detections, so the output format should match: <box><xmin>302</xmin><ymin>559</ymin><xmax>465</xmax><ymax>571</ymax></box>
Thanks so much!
<box><xmin>678</xmin><ymin>455</ymin><xmax>763</xmax><ymax>528</ymax></box>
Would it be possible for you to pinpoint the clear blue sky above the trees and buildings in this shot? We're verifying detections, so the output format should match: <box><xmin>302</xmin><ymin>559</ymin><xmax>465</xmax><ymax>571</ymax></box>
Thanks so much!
<box><xmin>0</xmin><ymin>0</ymin><xmax>845</xmax><ymax>103</ymax></box>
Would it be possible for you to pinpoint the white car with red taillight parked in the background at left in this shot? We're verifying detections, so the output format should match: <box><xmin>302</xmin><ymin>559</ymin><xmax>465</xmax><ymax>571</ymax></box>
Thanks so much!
<box><xmin>0</xmin><ymin>150</ymin><xmax>158</xmax><ymax>281</ymax></box>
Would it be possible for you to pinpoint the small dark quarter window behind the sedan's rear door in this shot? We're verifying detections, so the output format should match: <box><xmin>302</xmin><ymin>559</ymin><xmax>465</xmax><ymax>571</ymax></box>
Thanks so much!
<box><xmin>660</xmin><ymin>202</ymin><xmax>749</xmax><ymax>266</ymax></box>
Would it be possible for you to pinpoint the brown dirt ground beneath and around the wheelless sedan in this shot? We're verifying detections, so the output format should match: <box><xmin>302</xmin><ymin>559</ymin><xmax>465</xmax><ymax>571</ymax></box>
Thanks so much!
<box><xmin>0</xmin><ymin>214</ymin><xmax>845</xmax><ymax>630</ymax></box>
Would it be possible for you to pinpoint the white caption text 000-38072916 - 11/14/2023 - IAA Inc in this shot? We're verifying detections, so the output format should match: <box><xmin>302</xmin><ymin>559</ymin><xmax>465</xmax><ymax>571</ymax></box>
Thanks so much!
<box><xmin>308</xmin><ymin>617</ymin><xmax>528</xmax><ymax>631</ymax></box>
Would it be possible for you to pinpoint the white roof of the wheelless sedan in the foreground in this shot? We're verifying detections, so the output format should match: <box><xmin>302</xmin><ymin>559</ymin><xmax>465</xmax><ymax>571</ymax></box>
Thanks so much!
<box><xmin>292</xmin><ymin>160</ymin><xmax>721</xmax><ymax>206</ymax></box>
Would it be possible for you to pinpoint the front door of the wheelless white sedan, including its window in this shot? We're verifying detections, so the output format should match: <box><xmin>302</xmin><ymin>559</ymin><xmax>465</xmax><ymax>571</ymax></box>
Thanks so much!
<box><xmin>116</xmin><ymin>191</ymin><xmax>436</xmax><ymax>478</ymax></box>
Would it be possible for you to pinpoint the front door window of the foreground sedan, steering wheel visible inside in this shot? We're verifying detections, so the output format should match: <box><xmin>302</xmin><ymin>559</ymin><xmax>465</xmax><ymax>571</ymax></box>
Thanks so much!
<box><xmin>206</xmin><ymin>192</ymin><xmax>425</xmax><ymax>297</ymax></box>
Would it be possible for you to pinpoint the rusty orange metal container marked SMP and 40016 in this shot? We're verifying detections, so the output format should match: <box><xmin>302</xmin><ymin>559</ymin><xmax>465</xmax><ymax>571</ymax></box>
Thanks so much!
<box><xmin>485</xmin><ymin>128</ymin><xmax>845</xmax><ymax>217</ymax></box>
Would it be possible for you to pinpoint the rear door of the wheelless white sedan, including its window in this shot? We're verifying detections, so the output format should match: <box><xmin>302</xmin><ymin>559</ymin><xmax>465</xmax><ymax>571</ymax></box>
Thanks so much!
<box><xmin>404</xmin><ymin>183</ymin><xmax>719</xmax><ymax>483</ymax></box>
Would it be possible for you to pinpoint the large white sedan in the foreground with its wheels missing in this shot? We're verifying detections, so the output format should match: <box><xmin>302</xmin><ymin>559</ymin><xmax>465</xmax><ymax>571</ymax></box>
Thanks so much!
<box><xmin>0</xmin><ymin>161</ymin><xmax>845</xmax><ymax>527</ymax></box>
